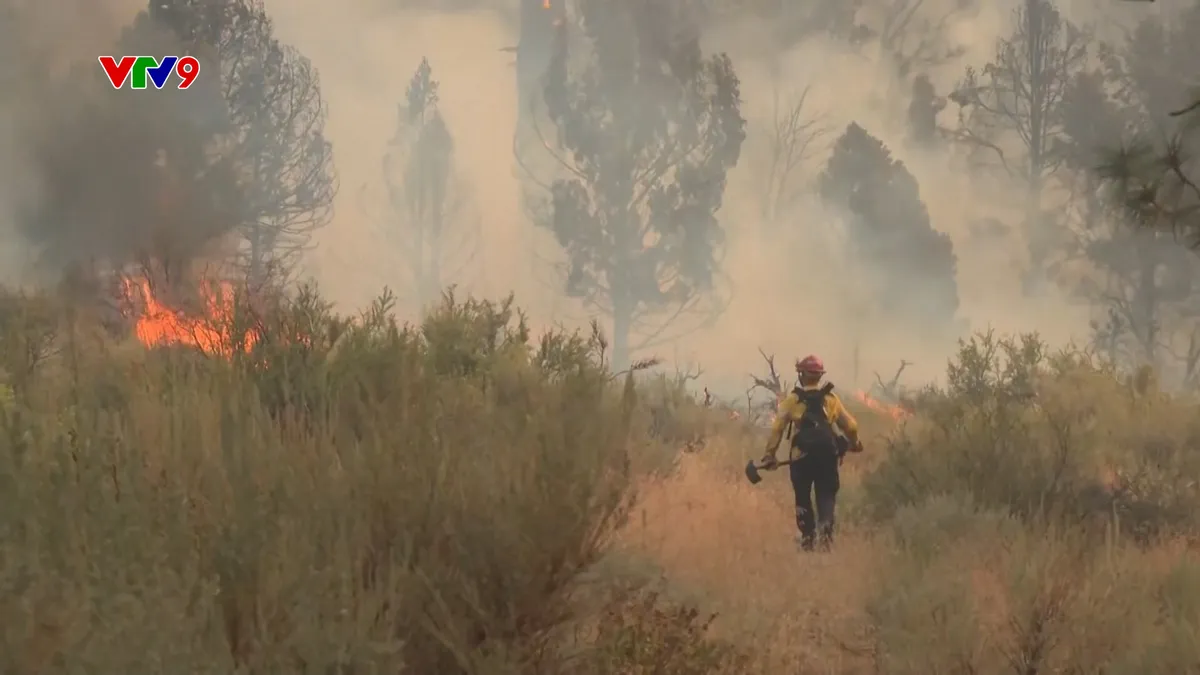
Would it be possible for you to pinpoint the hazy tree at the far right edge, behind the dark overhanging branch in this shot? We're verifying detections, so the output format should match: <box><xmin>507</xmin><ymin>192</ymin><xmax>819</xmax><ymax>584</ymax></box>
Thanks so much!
<box><xmin>1067</xmin><ymin>5</ymin><xmax>1200</xmax><ymax>388</ymax></box>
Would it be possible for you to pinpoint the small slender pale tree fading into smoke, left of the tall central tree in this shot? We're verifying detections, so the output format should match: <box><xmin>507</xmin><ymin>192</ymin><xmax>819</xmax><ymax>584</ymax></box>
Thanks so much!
<box><xmin>383</xmin><ymin>59</ymin><xmax>482</xmax><ymax>305</ymax></box>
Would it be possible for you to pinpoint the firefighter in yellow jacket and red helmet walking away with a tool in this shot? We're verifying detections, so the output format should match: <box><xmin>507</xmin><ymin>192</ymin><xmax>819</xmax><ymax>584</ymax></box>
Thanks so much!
<box><xmin>762</xmin><ymin>356</ymin><xmax>863</xmax><ymax>551</ymax></box>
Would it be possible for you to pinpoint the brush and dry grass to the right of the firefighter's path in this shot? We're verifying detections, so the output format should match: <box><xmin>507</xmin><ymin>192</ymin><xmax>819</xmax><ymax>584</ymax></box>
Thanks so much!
<box><xmin>852</xmin><ymin>334</ymin><xmax>1200</xmax><ymax>675</ymax></box>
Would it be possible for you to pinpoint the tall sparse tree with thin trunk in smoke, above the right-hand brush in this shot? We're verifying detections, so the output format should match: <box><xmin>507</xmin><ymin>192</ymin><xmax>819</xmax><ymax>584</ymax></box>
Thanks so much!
<box><xmin>949</xmin><ymin>0</ymin><xmax>1090</xmax><ymax>292</ymax></box>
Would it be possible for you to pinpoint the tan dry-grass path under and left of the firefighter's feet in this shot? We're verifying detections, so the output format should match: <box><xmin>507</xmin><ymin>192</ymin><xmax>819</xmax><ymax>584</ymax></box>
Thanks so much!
<box><xmin>623</xmin><ymin>448</ymin><xmax>874</xmax><ymax>674</ymax></box>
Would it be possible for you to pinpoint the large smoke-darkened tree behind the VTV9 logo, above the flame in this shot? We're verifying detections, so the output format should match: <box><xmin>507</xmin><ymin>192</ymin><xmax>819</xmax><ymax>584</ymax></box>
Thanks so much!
<box><xmin>24</xmin><ymin>0</ymin><xmax>337</xmax><ymax>286</ymax></box>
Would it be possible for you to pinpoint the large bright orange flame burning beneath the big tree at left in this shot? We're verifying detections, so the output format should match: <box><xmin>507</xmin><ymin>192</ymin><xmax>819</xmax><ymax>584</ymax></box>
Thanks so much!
<box><xmin>122</xmin><ymin>279</ymin><xmax>257</xmax><ymax>358</ymax></box>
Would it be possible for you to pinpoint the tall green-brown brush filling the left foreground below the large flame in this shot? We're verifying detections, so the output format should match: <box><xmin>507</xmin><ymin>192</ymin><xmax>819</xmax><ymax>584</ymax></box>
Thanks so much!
<box><xmin>0</xmin><ymin>283</ymin><xmax>734</xmax><ymax>675</ymax></box>
